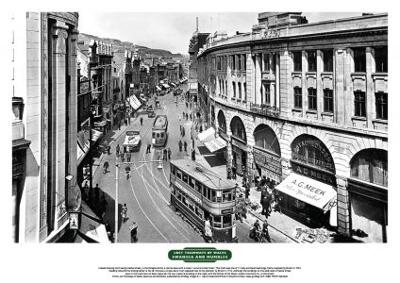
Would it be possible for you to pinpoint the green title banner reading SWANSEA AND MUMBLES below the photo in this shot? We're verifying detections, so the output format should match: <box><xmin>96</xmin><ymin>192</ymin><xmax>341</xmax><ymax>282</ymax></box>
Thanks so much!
<box><xmin>168</xmin><ymin>248</ymin><xmax>232</xmax><ymax>262</ymax></box>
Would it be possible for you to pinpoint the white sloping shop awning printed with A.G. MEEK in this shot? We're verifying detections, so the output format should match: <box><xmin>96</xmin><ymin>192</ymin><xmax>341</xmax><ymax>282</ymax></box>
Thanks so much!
<box><xmin>275</xmin><ymin>173</ymin><xmax>337</xmax><ymax>211</ymax></box>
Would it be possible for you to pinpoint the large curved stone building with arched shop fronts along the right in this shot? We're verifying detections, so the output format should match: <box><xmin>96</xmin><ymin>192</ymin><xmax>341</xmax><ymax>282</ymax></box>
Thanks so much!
<box><xmin>197</xmin><ymin>13</ymin><xmax>388</xmax><ymax>242</ymax></box>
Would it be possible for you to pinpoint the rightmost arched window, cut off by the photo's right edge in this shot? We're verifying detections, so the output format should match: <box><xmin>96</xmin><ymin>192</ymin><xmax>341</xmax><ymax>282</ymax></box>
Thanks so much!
<box><xmin>350</xmin><ymin>148</ymin><xmax>388</xmax><ymax>187</ymax></box>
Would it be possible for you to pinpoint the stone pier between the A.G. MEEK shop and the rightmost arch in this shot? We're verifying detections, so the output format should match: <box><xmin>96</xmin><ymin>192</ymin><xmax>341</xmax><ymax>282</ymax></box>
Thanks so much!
<box><xmin>336</xmin><ymin>176</ymin><xmax>351</xmax><ymax>236</ymax></box>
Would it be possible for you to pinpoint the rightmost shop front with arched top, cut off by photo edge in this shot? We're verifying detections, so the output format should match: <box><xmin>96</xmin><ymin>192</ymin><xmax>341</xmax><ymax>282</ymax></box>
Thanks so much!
<box><xmin>347</xmin><ymin>149</ymin><xmax>388</xmax><ymax>243</ymax></box>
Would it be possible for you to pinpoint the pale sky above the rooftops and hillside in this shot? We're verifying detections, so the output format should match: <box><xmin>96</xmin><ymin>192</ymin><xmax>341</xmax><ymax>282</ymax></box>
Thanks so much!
<box><xmin>79</xmin><ymin>12</ymin><xmax>361</xmax><ymax>54</ymax></box>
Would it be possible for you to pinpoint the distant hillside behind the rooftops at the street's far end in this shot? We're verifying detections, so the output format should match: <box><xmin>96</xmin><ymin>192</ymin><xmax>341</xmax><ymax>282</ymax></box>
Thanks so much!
<box><xmin>79</xmin><ymin>33</ymin><xmax>187</xmax><ymax>62</ymax></box>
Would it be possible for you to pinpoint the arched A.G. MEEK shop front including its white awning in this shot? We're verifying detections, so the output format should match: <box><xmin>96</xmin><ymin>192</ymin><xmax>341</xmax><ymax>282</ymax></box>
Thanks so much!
<box><xmin>276</xmin><ymin>135</ymin><xmax>337</xmax><ymax>227</ymax></box>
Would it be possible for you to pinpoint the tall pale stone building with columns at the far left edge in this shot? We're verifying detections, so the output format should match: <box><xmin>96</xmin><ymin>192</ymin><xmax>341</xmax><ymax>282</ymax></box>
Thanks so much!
<box><xmin>13</xmin><ymin>12</ymin><xmax>80</xmax><ymax>242</ymax></box>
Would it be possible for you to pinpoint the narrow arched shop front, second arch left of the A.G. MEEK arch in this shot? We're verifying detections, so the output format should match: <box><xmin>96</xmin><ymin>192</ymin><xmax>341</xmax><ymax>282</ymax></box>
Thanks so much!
<box><xmin>231</xmin><ymin>116</ymin><xmax>247</xmax><ymax>176</ymax></box>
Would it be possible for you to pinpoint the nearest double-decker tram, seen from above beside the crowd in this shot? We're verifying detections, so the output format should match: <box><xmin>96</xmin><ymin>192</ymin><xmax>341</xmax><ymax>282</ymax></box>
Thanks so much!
<box><xmin>170</xmin><ymin>159</ymin><xmax>237</xmax><ymax>242</ymax></box>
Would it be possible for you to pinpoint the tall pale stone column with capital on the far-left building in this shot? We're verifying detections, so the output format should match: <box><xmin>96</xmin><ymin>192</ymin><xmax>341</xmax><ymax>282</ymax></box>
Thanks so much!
<box><xmin>50</xmin><ymin>21</ymin><xmax>68</xmax><ymax>230</ymax></box>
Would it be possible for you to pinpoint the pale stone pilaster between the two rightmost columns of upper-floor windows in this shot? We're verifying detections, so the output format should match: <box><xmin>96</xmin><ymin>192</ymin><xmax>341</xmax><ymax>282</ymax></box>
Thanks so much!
<box><xmin>365</xmin><ymin>47</ymin><xmax>376</xmax><ymax>128</ymax></box>
